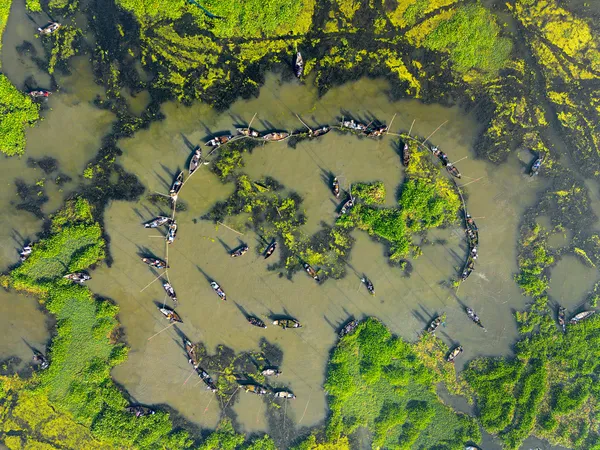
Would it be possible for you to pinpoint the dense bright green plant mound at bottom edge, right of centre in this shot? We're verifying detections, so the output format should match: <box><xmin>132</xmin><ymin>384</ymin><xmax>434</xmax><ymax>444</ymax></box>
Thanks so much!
<box><xmin>325</xmin><ymin>319</ymin><xmax>481</xmax><ymax>449</ymax></box>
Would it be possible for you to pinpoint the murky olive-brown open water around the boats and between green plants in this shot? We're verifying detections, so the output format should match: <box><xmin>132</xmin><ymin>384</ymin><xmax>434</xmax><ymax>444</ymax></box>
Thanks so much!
<box><xmin>0</xmin><ymin>2</ymin><xmax>598</xmax><ymax>448</ymax></box>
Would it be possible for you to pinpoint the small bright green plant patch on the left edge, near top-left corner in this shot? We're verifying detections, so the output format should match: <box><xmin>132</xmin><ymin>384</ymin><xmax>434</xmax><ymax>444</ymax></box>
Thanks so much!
<box><xmin>0</xmin><ymin>74</ymin><xmax>39</xmax><ymax>156</ymax></box>
